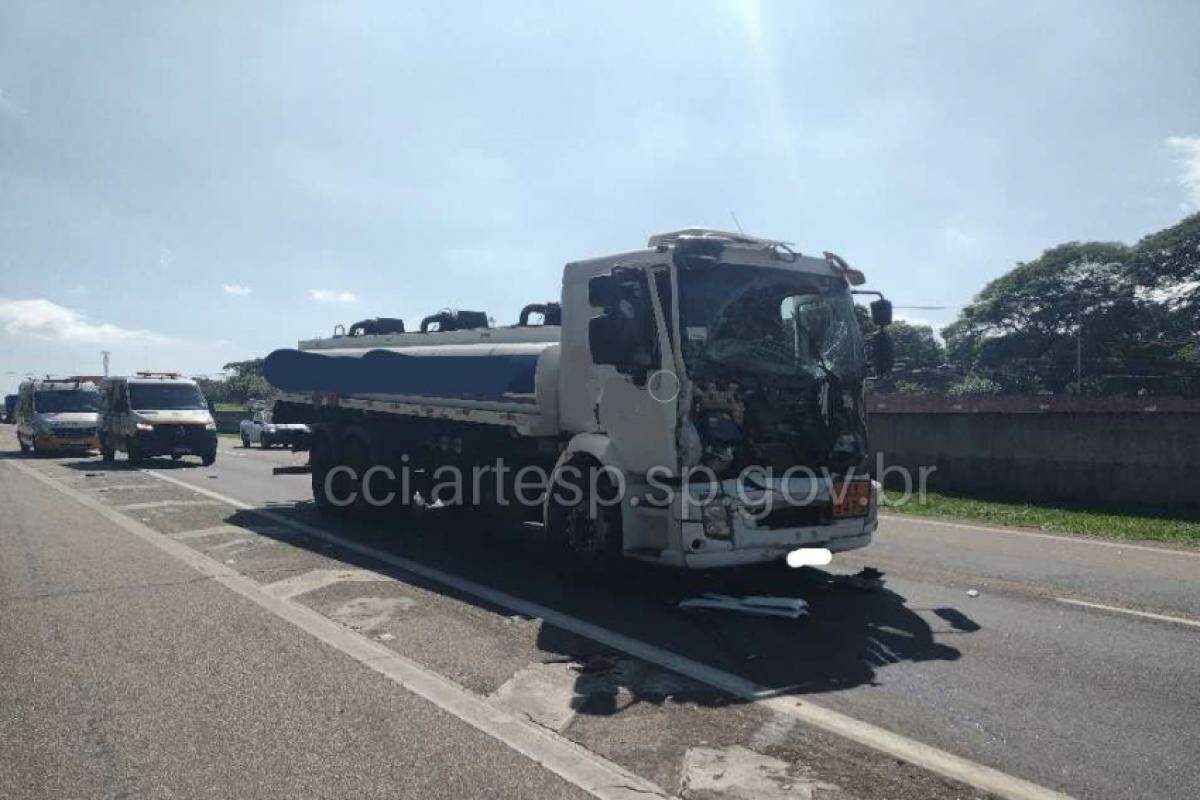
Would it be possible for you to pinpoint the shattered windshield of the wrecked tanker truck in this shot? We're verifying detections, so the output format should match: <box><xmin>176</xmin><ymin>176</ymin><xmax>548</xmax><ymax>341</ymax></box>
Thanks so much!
<box><xmin>680</xmin><ymin>264</ymin><xmax>866</xmax><ymax>381</ymax></box>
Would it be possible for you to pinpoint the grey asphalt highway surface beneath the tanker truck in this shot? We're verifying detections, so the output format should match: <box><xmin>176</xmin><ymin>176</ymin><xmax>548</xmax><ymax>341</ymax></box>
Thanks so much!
<box><xmin>0</xmin><ymin>434</ymin><xmax>1200</xmax><ymax>798</ymax></box>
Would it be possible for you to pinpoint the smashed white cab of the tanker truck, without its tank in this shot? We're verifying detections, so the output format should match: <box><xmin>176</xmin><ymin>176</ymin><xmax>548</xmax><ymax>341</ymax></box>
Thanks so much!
<box><xmin>560</xmin><ymin>229</ymin><xmax>890</xmax><ymax>569</ymax></box>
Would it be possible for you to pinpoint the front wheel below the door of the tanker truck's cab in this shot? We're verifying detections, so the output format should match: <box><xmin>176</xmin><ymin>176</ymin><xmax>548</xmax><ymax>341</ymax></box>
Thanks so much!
<box><xmin>546</xmin><ymin>462</ymin><xmax>623</xmax><ymax>577</ymax></box>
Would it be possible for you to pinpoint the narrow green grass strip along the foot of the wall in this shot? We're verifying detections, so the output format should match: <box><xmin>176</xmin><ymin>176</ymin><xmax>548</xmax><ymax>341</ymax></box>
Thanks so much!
<box><xmin>883</xmin><ymin>492</ymin><xmax>1200</xmax><ymax>545</ymax></box>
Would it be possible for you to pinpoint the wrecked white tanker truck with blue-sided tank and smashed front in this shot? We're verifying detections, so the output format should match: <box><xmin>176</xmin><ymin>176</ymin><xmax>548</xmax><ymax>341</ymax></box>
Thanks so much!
<box><xmin>263</xmin><ymin>228</ymin><xmax>892</xmax><ymax>569</ymax></box>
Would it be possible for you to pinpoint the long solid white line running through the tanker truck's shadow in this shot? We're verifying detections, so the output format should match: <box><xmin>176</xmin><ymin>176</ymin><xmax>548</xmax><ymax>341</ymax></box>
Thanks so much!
<box><xmin>140</xmin><ymin>473</ymin><xmax>1069</xmax><ymax>800</ymax></box>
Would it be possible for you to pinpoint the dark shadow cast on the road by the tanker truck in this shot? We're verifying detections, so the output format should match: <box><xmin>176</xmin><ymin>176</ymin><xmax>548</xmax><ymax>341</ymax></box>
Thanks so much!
<box><xmin>216</xmin><ymin>504</ymin><xmax>964</xmax><ymax>715</ymax></box>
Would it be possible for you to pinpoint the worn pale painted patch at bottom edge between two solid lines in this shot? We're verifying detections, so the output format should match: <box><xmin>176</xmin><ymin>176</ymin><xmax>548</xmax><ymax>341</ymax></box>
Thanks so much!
<box><xmin>679</xmin><ymin>746</ymin><xmax>842</xmax><ymax>800</ymax></box>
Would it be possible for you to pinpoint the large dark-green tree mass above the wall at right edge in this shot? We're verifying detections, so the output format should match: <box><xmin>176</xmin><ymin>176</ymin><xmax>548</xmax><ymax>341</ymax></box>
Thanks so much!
<box><xmin>943</xmin><ymin>220</ymin><xmax>1200</xmax><ymax>395</ymax></box>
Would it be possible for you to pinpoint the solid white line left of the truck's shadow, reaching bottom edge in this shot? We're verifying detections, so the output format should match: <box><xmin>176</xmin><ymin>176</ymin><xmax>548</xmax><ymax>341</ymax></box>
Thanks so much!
<box><xmin>7</xmin><ymin>461</ymin><xmax>670</xmax><ymax>800</ymax></box>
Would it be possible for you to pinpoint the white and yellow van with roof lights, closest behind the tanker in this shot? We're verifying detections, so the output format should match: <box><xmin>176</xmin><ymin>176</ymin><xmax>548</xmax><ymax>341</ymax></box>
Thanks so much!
<box><xmin>100</xmin><ymin>372</ymin><xmax>217</xmax><ymax>467</ymax></box>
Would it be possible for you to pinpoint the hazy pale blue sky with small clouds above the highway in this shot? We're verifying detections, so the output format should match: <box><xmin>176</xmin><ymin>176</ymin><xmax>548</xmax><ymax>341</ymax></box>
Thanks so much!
<box><xmin>0</xmin><ymin>0</ymin><xmax>1200</xmax><ymax>391</ymax></box>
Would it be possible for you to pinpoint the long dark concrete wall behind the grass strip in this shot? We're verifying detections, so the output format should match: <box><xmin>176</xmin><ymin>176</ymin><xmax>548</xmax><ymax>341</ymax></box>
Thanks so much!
<box><xmin>868</xmin><ymin>396</ymin><xmax>1200</xmax><ymax>507</ymax></box>
